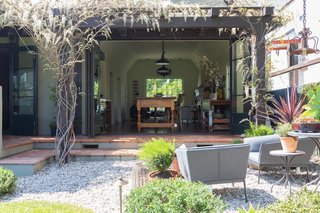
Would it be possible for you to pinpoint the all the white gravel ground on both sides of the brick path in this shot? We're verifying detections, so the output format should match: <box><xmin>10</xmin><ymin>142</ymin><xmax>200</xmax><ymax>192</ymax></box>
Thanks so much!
<box><xmin>0</xmin><ymin>158</ymin><xmax>320</xmax><ymax>213</ymax></box>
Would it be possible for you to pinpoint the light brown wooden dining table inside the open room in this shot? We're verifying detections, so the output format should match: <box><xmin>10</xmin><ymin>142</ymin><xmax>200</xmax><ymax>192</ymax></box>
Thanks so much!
<box><xmin>137</xmin><ymin>97</ymin><xmax>175</xmax><ymax>132</ymax></box>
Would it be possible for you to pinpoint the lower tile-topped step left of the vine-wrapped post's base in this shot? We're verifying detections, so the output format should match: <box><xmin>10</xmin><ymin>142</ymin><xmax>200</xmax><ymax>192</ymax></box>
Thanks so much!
<box><xmin>0</xmin><ymin>150</ymin><xmax>54</xmax><ymax>176</ymax></box>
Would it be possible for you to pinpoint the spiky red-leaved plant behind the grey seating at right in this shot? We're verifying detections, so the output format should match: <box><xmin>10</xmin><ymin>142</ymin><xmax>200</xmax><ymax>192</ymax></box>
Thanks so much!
<box><xmin>272</xmin><ymin>88</ymin><xmax>306</xmax><ymax>124</ymax></box>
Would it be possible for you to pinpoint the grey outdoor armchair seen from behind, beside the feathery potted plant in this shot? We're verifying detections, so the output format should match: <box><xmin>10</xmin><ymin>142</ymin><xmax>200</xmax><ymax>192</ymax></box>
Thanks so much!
<box><xmin>176</xmin><ymin>144</ymin><xmax>250</xmax><ymax>202</ymax></box>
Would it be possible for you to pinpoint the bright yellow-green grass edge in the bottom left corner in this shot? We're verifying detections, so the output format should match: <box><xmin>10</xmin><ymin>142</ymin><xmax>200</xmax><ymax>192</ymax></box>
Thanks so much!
<box><xmin>0</xmin><ymin>201</ymin><xmax>93</xmax><ymax>213</ymax></box>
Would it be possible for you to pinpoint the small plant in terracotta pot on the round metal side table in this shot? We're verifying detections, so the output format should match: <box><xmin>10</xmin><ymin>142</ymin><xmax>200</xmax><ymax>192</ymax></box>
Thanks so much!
<box><xmin>276</xmin><ymin>123</ymin><xmax>298</xmax><ymax>153</ymax></box>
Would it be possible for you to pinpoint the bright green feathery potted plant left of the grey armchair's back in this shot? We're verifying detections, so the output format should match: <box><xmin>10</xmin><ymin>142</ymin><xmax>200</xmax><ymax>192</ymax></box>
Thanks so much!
<box><xmin>138</xmin><ymin>138</ymin><xmax>177</xmax><ymax>178</ymax></box>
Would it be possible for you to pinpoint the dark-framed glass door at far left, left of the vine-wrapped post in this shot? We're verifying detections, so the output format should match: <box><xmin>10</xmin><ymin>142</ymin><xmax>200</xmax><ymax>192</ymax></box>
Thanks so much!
<box><xmin>9</xmin><ymin>47</ymin><xmax>38</xmax><ymax>135</ymax></box>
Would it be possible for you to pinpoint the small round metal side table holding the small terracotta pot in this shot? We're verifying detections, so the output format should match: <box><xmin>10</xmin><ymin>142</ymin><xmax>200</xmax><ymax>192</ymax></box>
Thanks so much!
<box><xmin>270</xmin><ymin>150</ymin><xmax>306</xmax><ymax>196</ymax></box>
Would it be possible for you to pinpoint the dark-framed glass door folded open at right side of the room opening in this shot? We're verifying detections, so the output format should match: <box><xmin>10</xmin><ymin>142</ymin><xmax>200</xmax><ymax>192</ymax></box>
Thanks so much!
<box><xmin>230</xmin><ymin>40</ymin><xmax>251</xmax><ymax>134</ymax></box>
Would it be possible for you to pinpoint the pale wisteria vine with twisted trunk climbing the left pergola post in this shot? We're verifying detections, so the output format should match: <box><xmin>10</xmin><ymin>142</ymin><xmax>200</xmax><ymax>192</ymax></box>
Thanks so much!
<box><xmin>0</xmin><ymin>0</ymin><xmax>205</xmax><ymax>165</ymax></box>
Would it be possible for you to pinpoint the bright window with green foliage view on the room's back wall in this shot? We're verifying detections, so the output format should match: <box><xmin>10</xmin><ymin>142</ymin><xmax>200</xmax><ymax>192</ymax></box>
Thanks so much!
<box><xmin>146</xmin><ymin>79</ymin><xmax>182</xmax><ymax>97</ymax></box>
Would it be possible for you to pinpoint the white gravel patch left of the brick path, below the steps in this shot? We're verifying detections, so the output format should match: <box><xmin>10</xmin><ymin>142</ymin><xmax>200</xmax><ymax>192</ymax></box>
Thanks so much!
<box><xmin>1</xmin><ymin>160</ymin><xmax>136</xmax><ymax>213</ymax></box>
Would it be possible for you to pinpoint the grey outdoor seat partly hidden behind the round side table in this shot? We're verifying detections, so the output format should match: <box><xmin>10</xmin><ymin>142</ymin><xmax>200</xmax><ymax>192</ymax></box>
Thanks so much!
<box><xmin>243</xmin><ymin>135</ymin><xmax>316</xmax><ymax>183</ymax></box>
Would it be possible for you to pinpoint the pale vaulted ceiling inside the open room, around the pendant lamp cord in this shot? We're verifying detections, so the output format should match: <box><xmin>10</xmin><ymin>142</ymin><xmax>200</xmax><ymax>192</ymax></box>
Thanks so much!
<box><xmin>100</xmin><ymin>40</ymin><xmax>229</xmax><ymax>76</ymax></box>
